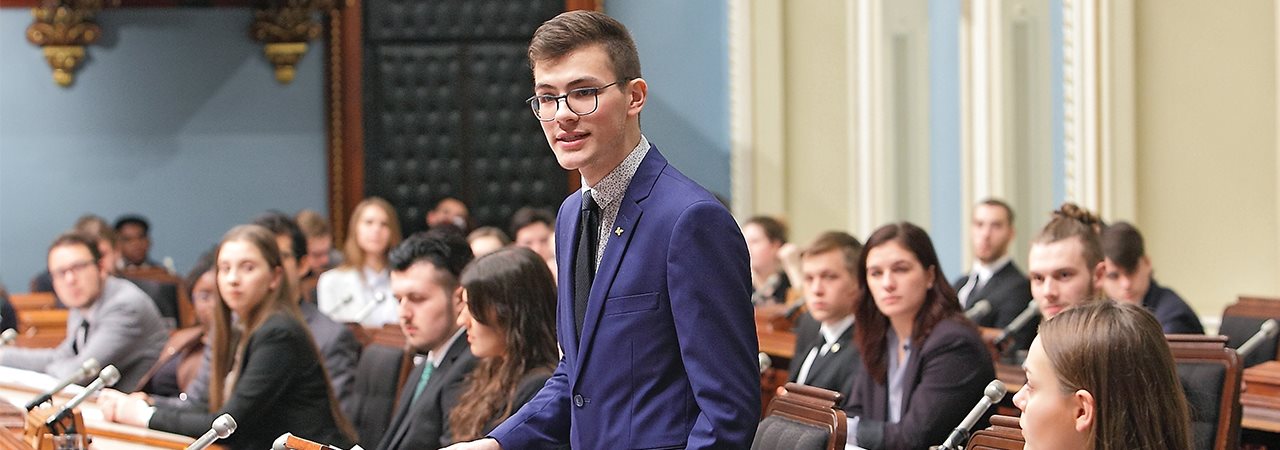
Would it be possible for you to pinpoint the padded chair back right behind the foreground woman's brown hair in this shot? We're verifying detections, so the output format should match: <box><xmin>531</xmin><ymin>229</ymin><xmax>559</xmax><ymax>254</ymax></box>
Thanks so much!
<box><xmin>1165</xmin><ymin>335</ymin><xmax>1244</xmax><ymax>450</ymax></box>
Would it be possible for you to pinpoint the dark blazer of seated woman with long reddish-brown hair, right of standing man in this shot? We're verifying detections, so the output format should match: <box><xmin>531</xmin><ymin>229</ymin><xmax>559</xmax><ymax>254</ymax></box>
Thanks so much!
<box><xmin>845</xmin><ymin>317</ymin><xmax>996</xmax><ymax>450</ymax></box>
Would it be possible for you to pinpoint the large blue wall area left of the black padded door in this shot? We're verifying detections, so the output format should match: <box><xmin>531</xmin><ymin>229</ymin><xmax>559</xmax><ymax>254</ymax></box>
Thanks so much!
<box><xmin>0</xmin><ymin>8</ymin><xmax>326</xmax><ymax>291</ymax></box>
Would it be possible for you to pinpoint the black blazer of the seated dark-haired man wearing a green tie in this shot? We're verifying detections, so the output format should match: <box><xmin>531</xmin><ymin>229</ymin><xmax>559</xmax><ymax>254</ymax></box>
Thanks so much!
<box><xmin>378</xmin><ymin>331</ymin><xmax>476</xmax><ymax>450</ymax></box>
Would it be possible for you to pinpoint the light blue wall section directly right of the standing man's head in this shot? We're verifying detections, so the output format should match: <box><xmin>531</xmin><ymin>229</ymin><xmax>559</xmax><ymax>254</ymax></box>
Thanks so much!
<box><xmin>605</xmin><ymin>0</ymin><xmax>730</xmax><ymax>199</ymax></box>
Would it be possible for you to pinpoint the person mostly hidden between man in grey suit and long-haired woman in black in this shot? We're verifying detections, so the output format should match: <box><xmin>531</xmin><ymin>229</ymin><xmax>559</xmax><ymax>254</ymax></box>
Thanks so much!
<box><xmin>134</xmin><ymin>251</ymin><xmax>221</xmax><ymax>398</ymax></box>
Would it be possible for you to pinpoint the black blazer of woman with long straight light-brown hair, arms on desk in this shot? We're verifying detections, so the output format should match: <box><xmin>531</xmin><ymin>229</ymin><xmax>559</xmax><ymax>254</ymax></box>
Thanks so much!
<box><xmin>148</xmin><ymin>312</ymin><xmax>352</xmax><ymax>449</ymax></box>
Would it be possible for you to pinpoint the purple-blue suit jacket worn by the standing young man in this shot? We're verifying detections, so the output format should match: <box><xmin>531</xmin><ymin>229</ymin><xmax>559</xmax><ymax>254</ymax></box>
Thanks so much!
<box><xmin>490</xmin><ymin>147</ymin><xmax>760</xmax><ymax>450</ymax></box>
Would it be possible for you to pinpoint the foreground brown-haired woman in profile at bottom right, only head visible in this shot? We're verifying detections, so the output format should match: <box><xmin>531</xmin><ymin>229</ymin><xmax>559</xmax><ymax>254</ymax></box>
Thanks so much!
<box><xmin>1014</xmin><ymin>300</ymin><xmax>1192</xmax><ymax>450</ymax></box>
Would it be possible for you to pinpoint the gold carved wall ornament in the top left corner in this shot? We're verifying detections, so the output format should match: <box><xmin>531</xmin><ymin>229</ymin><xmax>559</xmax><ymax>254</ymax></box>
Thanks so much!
<box><xmin>27</xmin><ymin>0</ymin><xmax>112</xmax><ymax>87</ymax></box>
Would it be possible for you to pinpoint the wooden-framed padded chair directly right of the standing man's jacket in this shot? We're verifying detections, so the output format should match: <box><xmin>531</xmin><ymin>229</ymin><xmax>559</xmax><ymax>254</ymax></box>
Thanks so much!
<box><xmin>751</xmin><ymin>382</ymin><xmax>849</xmax><ymax>450</ymax></box>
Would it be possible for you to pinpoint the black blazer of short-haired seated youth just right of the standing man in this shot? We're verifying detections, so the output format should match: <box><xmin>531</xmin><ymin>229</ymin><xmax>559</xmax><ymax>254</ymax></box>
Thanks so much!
<box><xmin>787</xmin><ymin>312</ymin><xmax>863</xmax><ymax>401</ymax></box>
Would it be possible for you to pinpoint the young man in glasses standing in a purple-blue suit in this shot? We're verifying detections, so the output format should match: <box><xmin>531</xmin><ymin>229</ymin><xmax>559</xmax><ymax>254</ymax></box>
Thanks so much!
<box><xmin>445</xmin><ymin>10</ymin><xmax>760</xmax><ymax>449</ymax></box>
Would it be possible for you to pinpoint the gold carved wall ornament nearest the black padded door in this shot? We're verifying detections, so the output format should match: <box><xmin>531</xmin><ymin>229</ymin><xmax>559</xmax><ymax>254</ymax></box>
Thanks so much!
<box><xmin>250</xmin><ymin>0</ymin><xmax>334</xmax><ymax>83</ymax></box>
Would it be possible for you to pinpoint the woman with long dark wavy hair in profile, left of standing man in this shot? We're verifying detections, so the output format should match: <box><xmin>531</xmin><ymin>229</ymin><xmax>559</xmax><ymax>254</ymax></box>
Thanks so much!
<box><xmin>449</xmin><ymin>248</ymin><xmax>559</xmax><ymax>442</ymax></box>
